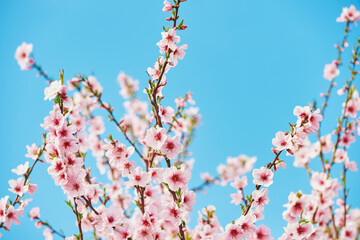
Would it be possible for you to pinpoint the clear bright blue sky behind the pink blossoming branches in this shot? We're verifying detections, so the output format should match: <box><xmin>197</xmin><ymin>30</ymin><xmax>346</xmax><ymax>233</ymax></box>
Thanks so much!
<box><xmin>0</xmin><ymin>0</ymin><xmax>360</xmax><ymax>239</ymax></box>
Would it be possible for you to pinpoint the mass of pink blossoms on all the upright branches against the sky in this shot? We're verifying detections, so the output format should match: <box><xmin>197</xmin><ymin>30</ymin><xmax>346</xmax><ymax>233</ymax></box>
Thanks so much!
<box><xmin>0</xmin><ymin>0</ymin><xmax>360</xmax><ymax>240</ymax></box>
